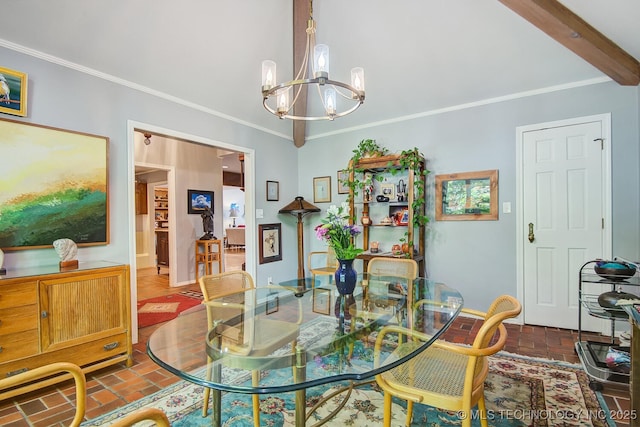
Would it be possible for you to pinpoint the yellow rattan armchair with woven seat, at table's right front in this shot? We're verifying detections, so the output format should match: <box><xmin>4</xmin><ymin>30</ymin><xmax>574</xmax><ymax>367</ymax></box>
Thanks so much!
<box><xmin>374</xmin><ymin>295</ymin><xmax>522</xmax><ymax>427</ymax></box>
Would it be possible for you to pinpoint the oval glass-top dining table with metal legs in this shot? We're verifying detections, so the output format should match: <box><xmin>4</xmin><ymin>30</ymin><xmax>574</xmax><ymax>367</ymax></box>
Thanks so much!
<box><xmin>147</xmin><ymin>274</ymin><xmax>463</xmax><ymax>426</ymax></box>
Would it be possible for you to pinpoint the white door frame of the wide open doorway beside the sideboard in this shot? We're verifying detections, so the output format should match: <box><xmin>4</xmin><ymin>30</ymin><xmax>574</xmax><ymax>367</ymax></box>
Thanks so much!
<box><xmin>127</xmin><ymin>120</ymin><xmax>257</xmax><ymax>344</ymax></box>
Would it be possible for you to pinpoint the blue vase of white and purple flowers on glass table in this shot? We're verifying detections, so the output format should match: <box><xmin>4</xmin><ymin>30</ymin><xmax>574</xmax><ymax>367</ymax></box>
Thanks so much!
<box><xmin>315</xmin><ymin>202</ymin><xmax>363</xmax><ymax>295</ymax></box>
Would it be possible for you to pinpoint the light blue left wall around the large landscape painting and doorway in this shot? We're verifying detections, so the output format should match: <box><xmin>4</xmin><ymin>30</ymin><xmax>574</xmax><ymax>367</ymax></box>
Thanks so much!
<box><xmin>0</xmin><ymin>48</ymin><xmax>298</xmax><ymax>288</ymax></box>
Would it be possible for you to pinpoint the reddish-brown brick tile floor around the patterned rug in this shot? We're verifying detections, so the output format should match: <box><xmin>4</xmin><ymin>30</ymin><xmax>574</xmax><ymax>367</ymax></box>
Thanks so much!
<box><xmin>0</xmin><ymin>256</ymin><xmax>629</xmax><ymax>427</ymax></box>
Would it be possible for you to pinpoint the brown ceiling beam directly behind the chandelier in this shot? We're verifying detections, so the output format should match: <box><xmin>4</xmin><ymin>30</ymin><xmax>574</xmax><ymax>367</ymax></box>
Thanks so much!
<box><xmin>291</xmin><ymin>0</ymin><xmax>311</xmax><ymax>147</ymax></box>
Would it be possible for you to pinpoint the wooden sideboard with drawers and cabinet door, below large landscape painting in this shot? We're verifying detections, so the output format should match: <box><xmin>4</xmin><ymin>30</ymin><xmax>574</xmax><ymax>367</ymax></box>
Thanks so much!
<box><xmin>0</xmin><ymin>261</ymin><xmax>133</xmax><ymax>399</ymax></box>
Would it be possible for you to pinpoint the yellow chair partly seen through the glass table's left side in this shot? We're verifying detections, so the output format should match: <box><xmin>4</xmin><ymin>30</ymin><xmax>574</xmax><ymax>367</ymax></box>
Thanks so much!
<box><xmin>199</xmin><ymin>271</ymin><xmax>302</xmax><ymax>427</ymax></box>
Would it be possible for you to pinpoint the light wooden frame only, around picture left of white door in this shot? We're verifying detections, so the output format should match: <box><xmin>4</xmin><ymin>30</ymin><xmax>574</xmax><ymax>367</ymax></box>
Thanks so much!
<box><xmin>436</xmin><ymin>169</ymin><xmax>498</xmax><ymax>221</ymax></box>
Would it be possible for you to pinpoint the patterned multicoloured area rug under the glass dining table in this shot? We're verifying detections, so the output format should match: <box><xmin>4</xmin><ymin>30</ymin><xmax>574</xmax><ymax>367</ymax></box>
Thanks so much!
<box><xmin>83</xmin><ymin>353</ymin><xmax>615</xmax><ymax>427</ymax></box>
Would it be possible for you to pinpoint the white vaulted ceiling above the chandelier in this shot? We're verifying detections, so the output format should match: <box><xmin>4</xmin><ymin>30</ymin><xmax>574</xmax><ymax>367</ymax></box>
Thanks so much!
<box><xmin>0</xmin><ymin>0</ymin><xmax>640</xmax><ymax>143</ymax></box>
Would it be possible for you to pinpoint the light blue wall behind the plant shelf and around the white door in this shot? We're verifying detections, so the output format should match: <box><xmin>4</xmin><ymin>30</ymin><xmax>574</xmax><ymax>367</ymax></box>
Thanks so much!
<box><xmin>299</xmin><ymin>83</ymin><xmax>640</xmax><ymax>307</ymax></box>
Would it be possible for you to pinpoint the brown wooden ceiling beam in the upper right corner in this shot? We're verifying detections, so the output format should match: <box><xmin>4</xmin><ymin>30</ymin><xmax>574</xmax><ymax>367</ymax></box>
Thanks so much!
<box><xmin>499</xmin><ymin>0</ymin><xmax>640</xmax><ymax>86</ymax></box>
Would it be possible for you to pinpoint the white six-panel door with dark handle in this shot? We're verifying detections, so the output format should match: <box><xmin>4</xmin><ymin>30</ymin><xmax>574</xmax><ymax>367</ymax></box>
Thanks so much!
<box><xmin>520</xmin><ymin>116</ymin><xmax>608</xmax><ymax>331</ymax></box>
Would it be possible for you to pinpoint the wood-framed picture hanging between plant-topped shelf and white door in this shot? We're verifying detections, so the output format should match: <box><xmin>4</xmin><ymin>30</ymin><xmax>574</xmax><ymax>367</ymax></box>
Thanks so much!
<box><xmin>436</xmin><ymin>169</ymin><xmax>498</xmax><ymax>221</ymax></box>
